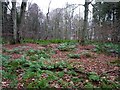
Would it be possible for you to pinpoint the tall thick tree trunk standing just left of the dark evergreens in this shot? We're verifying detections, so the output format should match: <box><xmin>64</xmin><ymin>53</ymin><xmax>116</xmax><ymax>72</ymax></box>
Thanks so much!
<box><xmin>80</xmin><ymin>0</ymin><xmax>89</xmax><ymax>45</ymax></box>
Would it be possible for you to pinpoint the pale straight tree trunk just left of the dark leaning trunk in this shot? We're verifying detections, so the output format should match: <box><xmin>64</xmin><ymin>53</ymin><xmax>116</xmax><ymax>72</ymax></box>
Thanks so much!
<box><xmin>12</xmin><ymin>1</ymin><xmax>17</xmax><ymax>44</ymax></box>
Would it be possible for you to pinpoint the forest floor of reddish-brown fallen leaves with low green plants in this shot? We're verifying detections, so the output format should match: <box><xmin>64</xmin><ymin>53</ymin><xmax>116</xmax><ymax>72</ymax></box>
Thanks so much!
<box><xmin>1</xmin><ymin>43</ymin><xmax>120</xmax><ymax>90</ymax></box>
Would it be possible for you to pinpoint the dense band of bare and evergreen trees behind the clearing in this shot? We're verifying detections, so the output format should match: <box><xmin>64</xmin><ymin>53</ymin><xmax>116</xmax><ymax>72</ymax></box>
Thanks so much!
<box><xmin>1</xmin><ymin>0</ymin><xmax>120</xmax><ymax>43</ymax></box>
